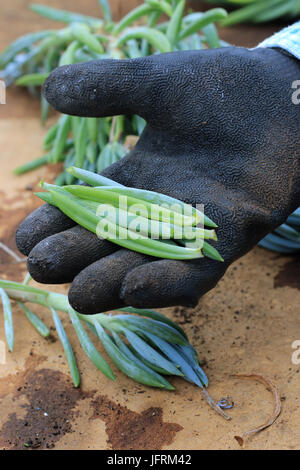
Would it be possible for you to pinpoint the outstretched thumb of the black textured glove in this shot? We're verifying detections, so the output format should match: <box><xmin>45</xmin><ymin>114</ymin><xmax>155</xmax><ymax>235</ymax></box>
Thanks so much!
<box><xmin>43</xmin><ymin>58</ymin><xmax>161</xmax><ymax>117</ymax></box>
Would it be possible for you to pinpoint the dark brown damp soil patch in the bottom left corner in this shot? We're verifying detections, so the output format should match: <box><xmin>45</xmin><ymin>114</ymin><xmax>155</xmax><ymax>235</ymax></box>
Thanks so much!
<box><xmin>0</xmin><ymin>355</ymin><xmax>94</xmax><ymax>450</ymax></box>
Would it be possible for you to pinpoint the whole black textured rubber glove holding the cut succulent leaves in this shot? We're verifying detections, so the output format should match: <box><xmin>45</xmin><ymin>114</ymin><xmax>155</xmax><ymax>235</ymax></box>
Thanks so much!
<box><xmin>16</xmin><ymin>47</ymin><xmax>300</xmax><ymax>314</ymax></box>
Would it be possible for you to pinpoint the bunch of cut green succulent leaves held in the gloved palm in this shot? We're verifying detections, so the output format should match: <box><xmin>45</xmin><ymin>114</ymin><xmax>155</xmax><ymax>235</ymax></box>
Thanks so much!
<box><xmin>36</xmin><ymin>167</ymin><xmax>223</xmax><ymax>261</ymax></box>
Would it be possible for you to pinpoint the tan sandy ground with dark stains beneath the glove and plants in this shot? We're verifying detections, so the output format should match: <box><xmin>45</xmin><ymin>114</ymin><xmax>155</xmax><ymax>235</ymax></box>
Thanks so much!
<box><xmin>0</xmin><ymin>0</ymin><xmax>300</xmax><ymax>449</ymax></box>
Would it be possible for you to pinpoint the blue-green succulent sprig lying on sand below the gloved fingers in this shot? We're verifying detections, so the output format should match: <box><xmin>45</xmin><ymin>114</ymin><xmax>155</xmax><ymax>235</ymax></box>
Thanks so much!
<box><xmin>0</xmin><ymin>279</ymin><xmax>231</xmax><ymax>420</ymax></box>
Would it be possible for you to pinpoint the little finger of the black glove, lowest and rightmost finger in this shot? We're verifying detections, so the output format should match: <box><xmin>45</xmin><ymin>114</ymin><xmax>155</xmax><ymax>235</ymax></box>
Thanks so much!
<box><xmin>120</xmin><ymin>258</ymin><xmax>227</xmax><ymax>308</ymax></box>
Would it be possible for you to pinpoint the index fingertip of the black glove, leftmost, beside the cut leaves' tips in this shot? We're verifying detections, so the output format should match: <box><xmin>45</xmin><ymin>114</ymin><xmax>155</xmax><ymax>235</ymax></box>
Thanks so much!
<box><xmin>16</xmin><ymin>204</ymin><xmax>75</xmax><ymax>256</ymax></box>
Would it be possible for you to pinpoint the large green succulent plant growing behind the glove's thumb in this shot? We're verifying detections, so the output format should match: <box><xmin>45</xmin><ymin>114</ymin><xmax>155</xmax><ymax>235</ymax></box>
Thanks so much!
<box><xmin>0</xmin><ymin>0</ymin><xmax>227</xmax><ymax>185</ymax></box>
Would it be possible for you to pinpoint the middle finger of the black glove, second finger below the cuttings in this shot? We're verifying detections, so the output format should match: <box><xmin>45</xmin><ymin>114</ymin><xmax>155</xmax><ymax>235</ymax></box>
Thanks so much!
<box><xmin>27</xmin><ymin>225</ymin><xmax>118</xmax><ymax>284</ymax></box>
